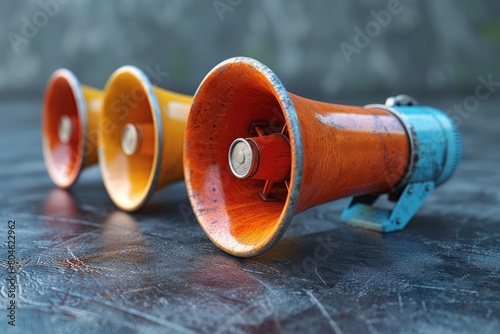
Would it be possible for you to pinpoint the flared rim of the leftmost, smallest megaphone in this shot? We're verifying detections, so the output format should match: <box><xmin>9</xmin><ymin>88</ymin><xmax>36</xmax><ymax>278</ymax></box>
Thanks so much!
<box><xmin>42</xmin><ymin>68</ymin><xmax>87</xmax><ymax>189</ymax></box>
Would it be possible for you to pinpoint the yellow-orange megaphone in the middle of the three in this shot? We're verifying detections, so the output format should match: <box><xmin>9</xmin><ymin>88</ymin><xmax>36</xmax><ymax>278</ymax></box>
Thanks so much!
<box><xmin>99</xmin><ymin>66</ymin><xmax>192</xmax><ymax>211</ymax></box>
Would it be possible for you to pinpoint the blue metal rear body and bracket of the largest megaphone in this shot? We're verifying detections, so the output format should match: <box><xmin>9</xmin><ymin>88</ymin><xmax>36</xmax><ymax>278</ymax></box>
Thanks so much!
<box><xmin>342</xmin><ymin>96</ymin><xmax>462</xmax><ymax>232</ymax></box>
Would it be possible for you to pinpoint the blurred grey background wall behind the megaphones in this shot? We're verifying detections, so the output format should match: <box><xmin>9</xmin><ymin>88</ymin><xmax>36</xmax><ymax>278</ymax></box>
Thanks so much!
<box><xmin>0</xmin><ymin>0</ymin><xmax>500</xmax><ymax>101</ymax></box>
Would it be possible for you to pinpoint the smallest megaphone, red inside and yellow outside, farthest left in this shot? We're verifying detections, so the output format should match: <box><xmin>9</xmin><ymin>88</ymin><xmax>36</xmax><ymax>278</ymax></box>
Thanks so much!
<box><xmin>42</xmin><ymin>69</ymin><xmax>102</xmax><ymax>188</ymax></box>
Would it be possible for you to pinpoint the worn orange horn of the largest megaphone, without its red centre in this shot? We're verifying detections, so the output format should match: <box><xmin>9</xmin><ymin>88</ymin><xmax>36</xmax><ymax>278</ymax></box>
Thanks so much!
<box><xmin>184</xmin><ymin>57</ymin><xmax>410</xmax><ymax>257</ymax></box>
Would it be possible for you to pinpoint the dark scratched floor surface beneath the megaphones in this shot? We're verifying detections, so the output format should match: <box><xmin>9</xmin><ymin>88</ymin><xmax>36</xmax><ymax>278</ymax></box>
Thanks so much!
<box><xmin>0</xmin><ymin>97</ymin><xmax>500</xmax><ymax>334</ymax></box>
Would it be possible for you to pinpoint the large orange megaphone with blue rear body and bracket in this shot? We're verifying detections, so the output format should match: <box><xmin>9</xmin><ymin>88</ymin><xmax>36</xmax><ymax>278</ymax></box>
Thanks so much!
<box><xmin>184</xmin><ymin>57</ymin><xmax>462</xmax><ymax>257</ymax></box>
